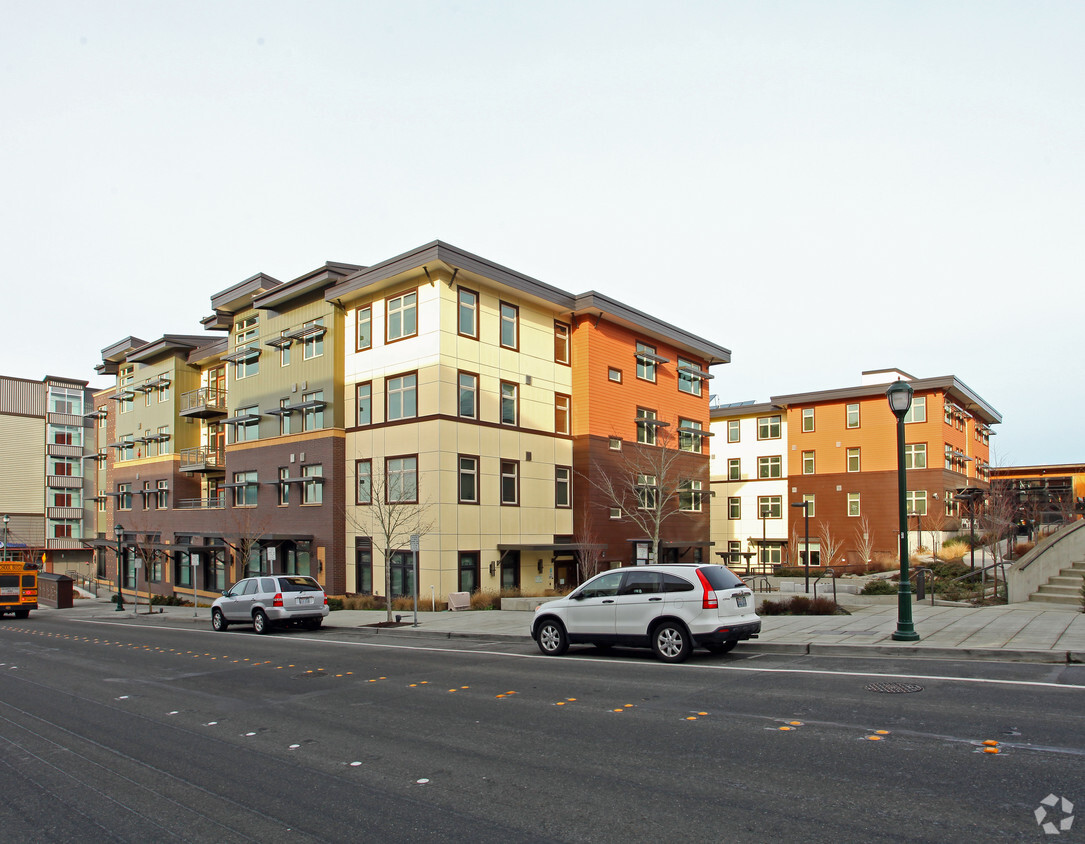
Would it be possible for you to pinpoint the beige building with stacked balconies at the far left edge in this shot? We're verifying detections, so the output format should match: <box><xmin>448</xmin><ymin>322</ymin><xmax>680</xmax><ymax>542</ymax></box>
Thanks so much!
<box><xmin>0</xmin><ymin>375</ymin><xmax>94</xmax><ymax>573</ymax></box>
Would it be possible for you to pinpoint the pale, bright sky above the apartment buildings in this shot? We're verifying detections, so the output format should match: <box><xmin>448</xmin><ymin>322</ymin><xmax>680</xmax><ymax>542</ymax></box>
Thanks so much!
<box><xmin>0</xmin><ymin>0</ymin><xmax>1085</xmax><ymax>465</ymax></box>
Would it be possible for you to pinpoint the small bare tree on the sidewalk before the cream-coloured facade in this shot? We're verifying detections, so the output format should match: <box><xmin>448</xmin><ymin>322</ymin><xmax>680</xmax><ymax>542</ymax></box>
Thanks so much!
<box><xmin>344</xmin><ymin>460</ymin><xmax>434</xmax><ymax>622</ymax></box>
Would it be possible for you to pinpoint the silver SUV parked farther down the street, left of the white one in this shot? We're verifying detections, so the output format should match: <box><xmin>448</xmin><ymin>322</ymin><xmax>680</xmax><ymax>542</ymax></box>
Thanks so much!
<box><xmin>210</xmin><ymin>574</ymin><xmax>328</xmax><ymax>634</ymax></box>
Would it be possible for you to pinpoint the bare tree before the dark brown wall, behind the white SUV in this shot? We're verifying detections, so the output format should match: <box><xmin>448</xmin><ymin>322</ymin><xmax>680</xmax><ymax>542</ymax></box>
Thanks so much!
<box><xmin>585</xmin><ymin>420</ymin><xmax>707</xmax><ymax>562</ymax></box>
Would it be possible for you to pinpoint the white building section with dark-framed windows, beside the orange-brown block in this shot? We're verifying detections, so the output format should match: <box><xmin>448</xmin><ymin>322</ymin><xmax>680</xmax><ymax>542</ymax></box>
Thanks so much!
<box><xmin>711</xmin><ymin>401</ymin><xmax>789</xmax><ymax>571</ymax></box>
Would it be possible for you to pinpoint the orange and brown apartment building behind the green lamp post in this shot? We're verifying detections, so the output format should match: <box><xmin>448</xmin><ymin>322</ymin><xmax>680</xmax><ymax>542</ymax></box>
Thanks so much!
<box><xmin>713</xmin><ymin>370</ymin><xmax>1001</xmax><ymax>566</ymax></box>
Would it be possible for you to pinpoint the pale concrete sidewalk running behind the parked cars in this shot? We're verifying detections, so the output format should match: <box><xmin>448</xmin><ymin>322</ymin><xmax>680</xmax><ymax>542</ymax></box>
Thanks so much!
<box><xmin>50</xmin><ymin>598</ymin><xmax>1085</xmax><ymax>663</ymax></box>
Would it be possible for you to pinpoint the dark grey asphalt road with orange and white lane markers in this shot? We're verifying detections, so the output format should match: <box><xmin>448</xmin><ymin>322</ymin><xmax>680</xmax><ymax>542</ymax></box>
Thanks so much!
<box><xmin>0</xmin><ymin>616</ymin><xmax>1085</xmax><ymax>843</ymax></box>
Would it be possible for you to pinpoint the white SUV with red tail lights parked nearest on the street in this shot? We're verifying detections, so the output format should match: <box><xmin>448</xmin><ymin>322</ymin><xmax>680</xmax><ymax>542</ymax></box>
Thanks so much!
<box><xmin>531</xmin><ymin>565</ymin><xmax>761</xmax><ymax>663</ymax></box>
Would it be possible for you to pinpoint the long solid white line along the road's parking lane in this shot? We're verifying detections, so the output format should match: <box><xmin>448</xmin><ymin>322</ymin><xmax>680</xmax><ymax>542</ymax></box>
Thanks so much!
<box><xmin>69</xmin><ymin>618</ymin><xmax>1085</xmax><ymax>691</ymax></box>
